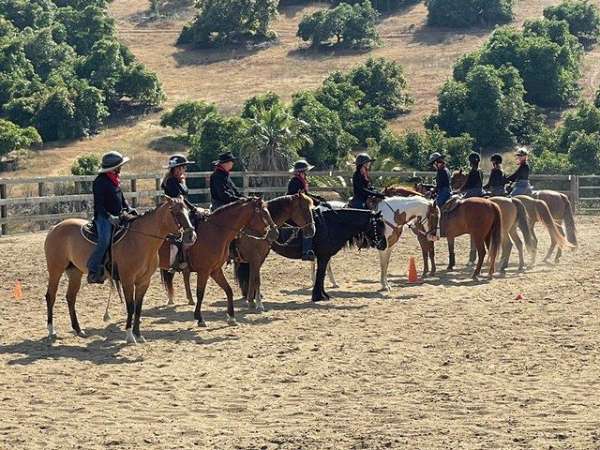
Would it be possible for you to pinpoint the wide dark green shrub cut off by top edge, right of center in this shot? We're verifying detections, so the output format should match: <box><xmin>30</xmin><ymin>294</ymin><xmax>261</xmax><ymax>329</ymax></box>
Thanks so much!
<box><xmin>425</xmin><ymin>0</ymin><xmax>513</xmax><ymax>28</ymax></box>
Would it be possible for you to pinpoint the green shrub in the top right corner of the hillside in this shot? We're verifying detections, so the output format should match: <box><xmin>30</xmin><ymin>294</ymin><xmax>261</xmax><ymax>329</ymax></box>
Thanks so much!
<box><xmin>544</xmin><ymin>0</ymin><xmax>600</xmax><ymax>47</ymax></box>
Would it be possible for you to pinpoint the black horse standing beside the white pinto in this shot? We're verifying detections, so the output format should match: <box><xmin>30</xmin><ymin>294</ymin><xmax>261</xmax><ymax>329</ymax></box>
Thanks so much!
<box><xmin>272</xmin><ymin>208</ymin><xmax>387</xmax><ymax>302</ymax></box>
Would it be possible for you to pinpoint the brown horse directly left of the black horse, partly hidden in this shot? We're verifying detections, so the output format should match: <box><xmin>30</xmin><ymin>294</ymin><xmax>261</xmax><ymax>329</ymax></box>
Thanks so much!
<box><xmin>235</xmin><ymin>193</ymin><xmax>315</xmax><ymax>311</ymax></box>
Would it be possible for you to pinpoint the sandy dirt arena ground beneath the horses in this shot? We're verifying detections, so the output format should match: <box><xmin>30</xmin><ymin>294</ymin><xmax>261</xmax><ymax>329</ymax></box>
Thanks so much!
<box><xmin>0</xmin><ymin>217</ymin><xmax>600</xmax><ymax>449</ymax></box>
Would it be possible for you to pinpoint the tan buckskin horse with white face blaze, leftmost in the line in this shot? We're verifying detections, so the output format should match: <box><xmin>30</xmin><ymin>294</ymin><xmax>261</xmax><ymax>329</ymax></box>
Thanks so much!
<box><xmin>44</xmin><ymin>197</ymin><xmax>196</xmax><ymax>344</ymax></box>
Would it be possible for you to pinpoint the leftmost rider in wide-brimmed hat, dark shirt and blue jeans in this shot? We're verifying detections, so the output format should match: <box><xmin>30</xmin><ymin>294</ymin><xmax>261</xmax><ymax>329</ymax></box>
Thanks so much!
<box><xmin>87</xmin><ymin>151</ymin><xmax>137</xmax><ymax>284</ymax></box>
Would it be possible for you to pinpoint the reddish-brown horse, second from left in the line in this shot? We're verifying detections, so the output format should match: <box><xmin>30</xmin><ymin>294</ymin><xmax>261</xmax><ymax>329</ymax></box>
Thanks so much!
<box><xmin>160</xmin><ymin>198</ymin><xmax>279</xmax><ymax>327</ymax></box>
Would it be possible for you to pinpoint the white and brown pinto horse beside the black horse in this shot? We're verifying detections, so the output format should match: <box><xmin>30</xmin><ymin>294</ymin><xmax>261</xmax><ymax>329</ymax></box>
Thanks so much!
<box><xmin>376</xmin><ymin>195</ymin><xmax>439</xmax><ymax>291</ymax></box>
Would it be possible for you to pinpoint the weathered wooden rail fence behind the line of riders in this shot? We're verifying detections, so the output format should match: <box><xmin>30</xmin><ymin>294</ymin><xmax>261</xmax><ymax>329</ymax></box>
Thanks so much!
<box><xmin>0</xmin><ymin>171</ymin><xmax>600</xmax><ymax>236</ymax></box>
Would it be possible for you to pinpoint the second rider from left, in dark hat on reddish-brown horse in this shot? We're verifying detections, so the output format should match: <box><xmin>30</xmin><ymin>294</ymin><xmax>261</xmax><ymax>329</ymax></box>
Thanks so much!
<box><xmin>161</xmin><ymin>154</ymin><xmax>197</xmax><ymax>270</ymax></box>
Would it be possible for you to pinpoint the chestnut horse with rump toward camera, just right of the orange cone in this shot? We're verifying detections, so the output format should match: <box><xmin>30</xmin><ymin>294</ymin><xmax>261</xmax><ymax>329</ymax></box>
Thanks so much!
<box><xmin>440</xmin><ymin>197</ymin><xmax>502</xmax><ymax>280</ymax></box>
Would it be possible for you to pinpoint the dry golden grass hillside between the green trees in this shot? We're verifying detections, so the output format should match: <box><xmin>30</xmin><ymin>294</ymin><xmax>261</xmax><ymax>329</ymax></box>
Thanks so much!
<box><xmin>7</xmin><ymin>0</ymin><xmax>600</xmax><ymax>176</ymax></box>
